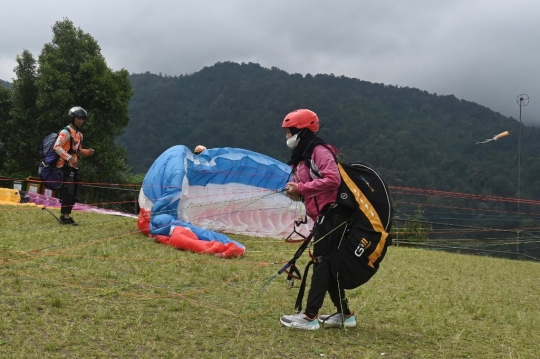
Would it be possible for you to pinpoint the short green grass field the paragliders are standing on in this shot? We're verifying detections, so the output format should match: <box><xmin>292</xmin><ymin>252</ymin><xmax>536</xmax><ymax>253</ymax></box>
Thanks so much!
<box><xmin>0</xmin><ymin>206</ymin><xmax>540</xmax><ymax>358</ymax></box>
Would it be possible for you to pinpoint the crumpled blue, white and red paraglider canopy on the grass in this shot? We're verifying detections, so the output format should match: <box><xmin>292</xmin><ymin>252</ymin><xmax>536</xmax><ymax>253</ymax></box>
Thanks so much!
<box><xmin>138</xmin><ymin>145</ymin><xmax>308</xmax><ymax>257</ymax></box>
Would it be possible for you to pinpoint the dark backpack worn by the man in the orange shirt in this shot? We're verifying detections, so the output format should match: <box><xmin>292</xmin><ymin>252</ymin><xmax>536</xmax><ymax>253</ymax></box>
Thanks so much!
<box><xmin>38</xmin><ymin>126</ymin><xmax>73</xmax><ymax>191</ymax></box>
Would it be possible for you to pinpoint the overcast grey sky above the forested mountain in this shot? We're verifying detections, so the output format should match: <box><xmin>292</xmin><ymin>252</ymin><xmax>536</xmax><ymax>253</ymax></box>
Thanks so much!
<box><xmin>0</xmin><ymin>0</ymin><xmax>540</xmax><ymax>124</ymax></box>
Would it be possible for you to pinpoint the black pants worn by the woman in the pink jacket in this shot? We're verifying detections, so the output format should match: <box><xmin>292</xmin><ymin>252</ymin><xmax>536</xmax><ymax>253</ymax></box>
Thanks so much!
<box><xmin>305</xmin><ymin>206</ymin><xmax>352</xmax><ymax>316</ymax></box>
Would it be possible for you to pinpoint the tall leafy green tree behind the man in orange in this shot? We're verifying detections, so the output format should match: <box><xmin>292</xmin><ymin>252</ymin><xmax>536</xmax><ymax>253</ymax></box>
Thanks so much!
<box><xmin>3</xmin><ymin>19</ymin><xmax>133</xmax><ymax>182</ymax></box>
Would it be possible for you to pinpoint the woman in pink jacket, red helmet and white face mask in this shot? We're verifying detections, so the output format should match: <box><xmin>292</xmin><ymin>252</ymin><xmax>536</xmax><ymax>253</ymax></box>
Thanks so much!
<box><xmin>280</xmin><ymin>109</ymin><xmax>356</xmax><ymax>330</ymax></box>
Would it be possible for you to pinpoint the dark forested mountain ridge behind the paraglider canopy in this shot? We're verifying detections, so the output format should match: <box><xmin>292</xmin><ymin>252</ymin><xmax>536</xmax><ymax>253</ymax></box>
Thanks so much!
<box><xmin>118</xmin><ymin>62</ymin><xmax>540</xmax><ymax>202</ymax></box>
